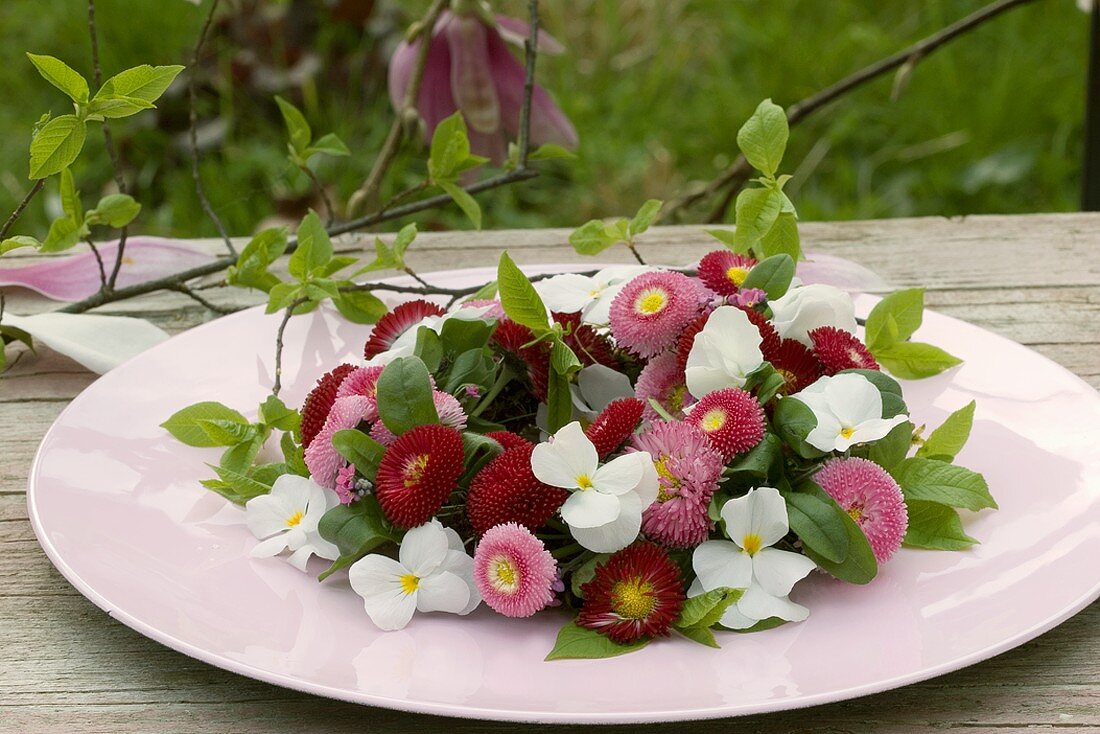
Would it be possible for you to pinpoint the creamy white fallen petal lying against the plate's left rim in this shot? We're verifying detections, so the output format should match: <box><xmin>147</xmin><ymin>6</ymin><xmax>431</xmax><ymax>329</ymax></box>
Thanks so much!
<box><xmin>3</xmin><ymin>313</ymin><xmax>168</xmax><ymax>374</ymax></box>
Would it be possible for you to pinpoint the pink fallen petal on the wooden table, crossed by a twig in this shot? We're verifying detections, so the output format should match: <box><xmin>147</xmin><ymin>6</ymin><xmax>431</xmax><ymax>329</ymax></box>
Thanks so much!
<box><xmin>0</xmin><ymin>237</ymin><xmax>211</xmax><ymax>302</ymax></box>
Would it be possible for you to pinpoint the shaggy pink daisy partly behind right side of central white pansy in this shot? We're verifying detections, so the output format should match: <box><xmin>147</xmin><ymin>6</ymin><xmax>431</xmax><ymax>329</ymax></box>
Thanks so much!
<box><xmin>627</xmin><ymin>420</ymin><xmax>724</xmax><ymax>548</ymax></box>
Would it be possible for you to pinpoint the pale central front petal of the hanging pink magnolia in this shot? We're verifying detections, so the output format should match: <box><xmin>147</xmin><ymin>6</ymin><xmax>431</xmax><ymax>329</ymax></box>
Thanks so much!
<box><xmin>444</xmin><ymin>15</ymin><xmax>501</xmax><ymax>133</ymax></box>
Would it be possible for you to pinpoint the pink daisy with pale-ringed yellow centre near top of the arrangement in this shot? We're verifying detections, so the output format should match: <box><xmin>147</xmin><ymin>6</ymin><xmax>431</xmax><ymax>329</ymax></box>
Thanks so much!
<box><xmin>611</xmin><ymin>271</ymin><xmax>706</xmax><ymax>358</ymax></box>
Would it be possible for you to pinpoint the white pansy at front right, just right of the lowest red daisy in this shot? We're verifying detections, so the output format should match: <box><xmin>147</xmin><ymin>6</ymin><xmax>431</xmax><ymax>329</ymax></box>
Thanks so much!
<box><xmin>688</xmin><ymin>486</ymin><xmax>816</xmax><ymax>629</ymax></box>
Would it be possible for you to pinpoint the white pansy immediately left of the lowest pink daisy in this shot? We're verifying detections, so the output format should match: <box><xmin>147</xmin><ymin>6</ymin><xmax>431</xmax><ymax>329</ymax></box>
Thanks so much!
<box><xmin>348</xmin><ymin>519</ymin><xmax>481</xmax><ymax>631</ymax></box>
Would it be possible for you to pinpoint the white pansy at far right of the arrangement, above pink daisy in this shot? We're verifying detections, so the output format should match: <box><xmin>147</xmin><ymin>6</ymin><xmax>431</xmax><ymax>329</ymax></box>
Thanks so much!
<box><xmin>796</xmin><ymin>372</ymin><xmax>909</xmax><ymax>451</ymax></box>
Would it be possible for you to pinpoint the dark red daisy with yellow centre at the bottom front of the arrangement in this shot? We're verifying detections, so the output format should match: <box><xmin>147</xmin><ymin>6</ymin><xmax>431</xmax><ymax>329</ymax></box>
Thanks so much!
<box><xmin>576</xmin><ymin>541</ymin><xmax>684</xmax><ymax>645</ymax></box>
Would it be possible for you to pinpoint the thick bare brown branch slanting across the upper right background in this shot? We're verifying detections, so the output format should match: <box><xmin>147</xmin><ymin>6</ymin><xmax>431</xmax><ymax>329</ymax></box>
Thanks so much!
<box><xmin>664</xmin><ymin>0</ymin><xmax>1034</xmax><ymax>221</ymax></box>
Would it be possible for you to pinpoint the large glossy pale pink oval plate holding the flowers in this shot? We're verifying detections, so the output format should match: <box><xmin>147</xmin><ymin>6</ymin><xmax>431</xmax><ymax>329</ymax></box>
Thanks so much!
<box><xmin>29</xmin><ymin>269</ymin><xmax>1100</xmax><ymax>723</ymax></box>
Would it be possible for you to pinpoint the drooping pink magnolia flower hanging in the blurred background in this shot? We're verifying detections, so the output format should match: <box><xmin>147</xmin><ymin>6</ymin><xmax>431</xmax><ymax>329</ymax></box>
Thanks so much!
<box><xmin>389</xmin><ymin>11</ymin><xmax>578</xmax><ymax>163</ymax></box>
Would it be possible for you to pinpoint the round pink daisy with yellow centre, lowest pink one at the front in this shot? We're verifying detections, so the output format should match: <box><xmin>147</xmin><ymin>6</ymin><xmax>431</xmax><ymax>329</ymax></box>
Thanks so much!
<box><xmin>474</xmin><ymin>523</ymin><xmax>558</xmax><ymax>617</ymax></box>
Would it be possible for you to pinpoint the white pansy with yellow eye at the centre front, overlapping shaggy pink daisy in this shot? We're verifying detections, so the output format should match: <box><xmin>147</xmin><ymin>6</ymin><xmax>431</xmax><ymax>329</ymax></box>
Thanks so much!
<box><xmin>531</xmin><ymin>420</ymin><xmax>658</xmax><ymax>554</ymax></box>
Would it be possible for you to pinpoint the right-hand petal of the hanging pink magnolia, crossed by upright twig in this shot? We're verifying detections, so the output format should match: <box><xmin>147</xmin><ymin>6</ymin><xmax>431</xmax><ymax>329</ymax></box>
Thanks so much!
<box><xmin>488</xmin><ymin>33</ymin><xmax>578</xmax><ymax>149</ymax></box>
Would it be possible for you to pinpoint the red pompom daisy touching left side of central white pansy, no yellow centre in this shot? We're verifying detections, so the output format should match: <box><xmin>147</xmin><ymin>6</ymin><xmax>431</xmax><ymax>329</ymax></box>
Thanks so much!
<box><xmin>466</xmin><ymin>443</ymin><xmax>569</xmax><ymax>535</ymax></box>
